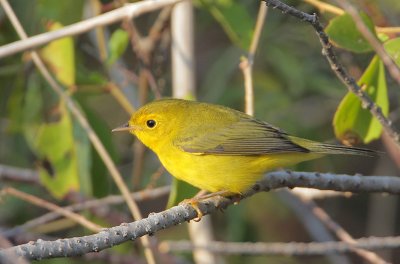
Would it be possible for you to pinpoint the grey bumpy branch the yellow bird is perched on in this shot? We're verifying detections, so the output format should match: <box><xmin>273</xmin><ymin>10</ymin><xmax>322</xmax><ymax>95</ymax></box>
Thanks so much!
<box><xmin>0</xmin><ymin>171</ymin><xmax>400</xmax><ymax>262</ymax></box>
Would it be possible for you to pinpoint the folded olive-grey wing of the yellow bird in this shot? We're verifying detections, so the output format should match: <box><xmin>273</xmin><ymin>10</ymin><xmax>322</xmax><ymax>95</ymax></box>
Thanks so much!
<box><xmin>174</xmin><ymin>118</ymin><xmax>309</xmax><ymax>155</ymax></box>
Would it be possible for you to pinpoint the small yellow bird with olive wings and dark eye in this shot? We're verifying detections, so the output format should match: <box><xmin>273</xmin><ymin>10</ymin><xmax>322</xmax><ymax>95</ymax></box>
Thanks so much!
<box><xmin>113</xmin><ymin>99</ymin><xmax>374</xmax><ymax>216</ymax></box>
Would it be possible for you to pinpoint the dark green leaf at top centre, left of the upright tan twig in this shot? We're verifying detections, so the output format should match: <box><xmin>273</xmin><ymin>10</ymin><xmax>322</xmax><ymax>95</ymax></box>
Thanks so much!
<box><xmin>198</xmin><ymin>0</ymin><xmax>255</xmax><ymax>50</ymax></box>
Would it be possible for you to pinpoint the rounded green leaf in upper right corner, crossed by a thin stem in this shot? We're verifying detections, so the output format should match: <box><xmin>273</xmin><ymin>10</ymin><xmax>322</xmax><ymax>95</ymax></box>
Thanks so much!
<box><xmin>325</xmin><ymin>12</ymin><xmax>376</xmax><ymax>53</ymax></box>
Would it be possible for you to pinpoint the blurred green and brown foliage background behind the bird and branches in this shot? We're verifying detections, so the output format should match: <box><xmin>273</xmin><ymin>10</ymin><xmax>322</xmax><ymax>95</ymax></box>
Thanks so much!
<box><xmin>0</xmin><ymin>0</ymin><xmax>400</xmax><ymax>263</ymax></box>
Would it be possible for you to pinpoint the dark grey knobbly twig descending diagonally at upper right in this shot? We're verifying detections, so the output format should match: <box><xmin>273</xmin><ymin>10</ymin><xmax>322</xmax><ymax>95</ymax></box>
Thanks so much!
<box><xmin>263</xmin><ymin>0</ymin><xmax>400</xmax><ymax>146</ymax></box>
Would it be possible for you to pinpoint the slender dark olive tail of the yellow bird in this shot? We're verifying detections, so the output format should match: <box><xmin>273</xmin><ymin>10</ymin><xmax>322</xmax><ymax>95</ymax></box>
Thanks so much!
<box><xmin>290</xmin><ymin>137</ymin><xmax>379</xmax><ymax>157</ymax></box>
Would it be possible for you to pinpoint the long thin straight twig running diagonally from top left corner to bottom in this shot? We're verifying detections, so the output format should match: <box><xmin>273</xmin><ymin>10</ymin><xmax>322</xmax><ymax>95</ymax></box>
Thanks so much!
<box><xmin>0</xmin><ymin>0</ymin><xmax>156</xmax><ymax>262</ymax></box>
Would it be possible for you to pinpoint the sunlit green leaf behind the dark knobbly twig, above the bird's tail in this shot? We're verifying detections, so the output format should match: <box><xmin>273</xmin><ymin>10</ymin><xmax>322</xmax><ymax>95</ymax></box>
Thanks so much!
<box><xmin>333</xmin><ymin>56</ymin><xmax>389</xmax><ymax>145</ymax></box>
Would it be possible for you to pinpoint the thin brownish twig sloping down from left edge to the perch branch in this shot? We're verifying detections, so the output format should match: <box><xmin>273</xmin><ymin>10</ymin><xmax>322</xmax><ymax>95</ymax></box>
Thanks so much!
<box><xmin>1</xmin><ymin>187</ymin><xmax>102</xmax><ymax>232</ymax></box>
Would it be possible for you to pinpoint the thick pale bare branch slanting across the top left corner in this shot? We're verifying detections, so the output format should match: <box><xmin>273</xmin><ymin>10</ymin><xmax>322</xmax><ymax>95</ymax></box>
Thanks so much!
<box><xmin>0</xmin><ymin>0</ymin><xmax>182</xmax><ymax>58</ymax></box>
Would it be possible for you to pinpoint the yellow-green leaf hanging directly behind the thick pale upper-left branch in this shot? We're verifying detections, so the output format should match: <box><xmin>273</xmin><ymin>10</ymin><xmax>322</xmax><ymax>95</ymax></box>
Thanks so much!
<box><xmin>40</xmin><ymin>22</ymin><xmax>75</xmax><ymax>87</ymax></box>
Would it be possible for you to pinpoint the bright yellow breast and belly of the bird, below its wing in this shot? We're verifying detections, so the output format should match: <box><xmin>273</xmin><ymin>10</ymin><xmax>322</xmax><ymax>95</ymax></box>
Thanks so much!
<box><xmin>157</xmin><ymin>143</ymin><xmax>321</xmax><ymax>193</ymax></box>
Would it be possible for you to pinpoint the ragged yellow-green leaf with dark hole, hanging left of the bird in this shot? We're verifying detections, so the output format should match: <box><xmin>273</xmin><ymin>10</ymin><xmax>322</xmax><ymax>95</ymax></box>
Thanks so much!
<box><xmin>24</xmin><ymin>99</ymin><xmax>82</xmax><ymax>198</ymax></box>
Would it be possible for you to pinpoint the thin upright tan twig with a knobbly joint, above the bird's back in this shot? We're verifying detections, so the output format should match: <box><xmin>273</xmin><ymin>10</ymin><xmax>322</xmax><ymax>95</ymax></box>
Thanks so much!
<box><xmin>239</xmin><ymin>2</ymin><xmax>267</xmax><ymax>115</ymax></box>
